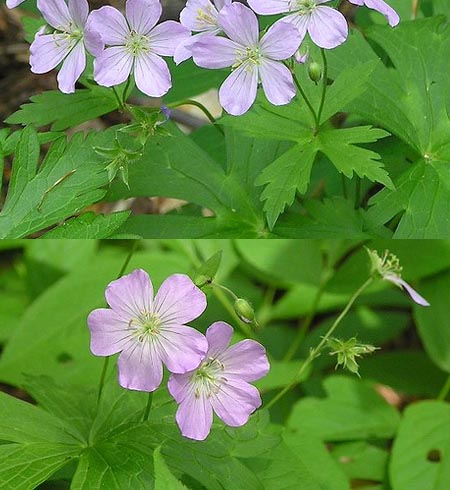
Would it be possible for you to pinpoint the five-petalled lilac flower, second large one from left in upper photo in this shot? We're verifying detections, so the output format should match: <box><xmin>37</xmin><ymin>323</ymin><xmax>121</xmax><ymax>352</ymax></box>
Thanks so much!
<box><xmin>89</xmin><ymin>0</ymin><xmax>189</xmax><ymax>97</ymax></box>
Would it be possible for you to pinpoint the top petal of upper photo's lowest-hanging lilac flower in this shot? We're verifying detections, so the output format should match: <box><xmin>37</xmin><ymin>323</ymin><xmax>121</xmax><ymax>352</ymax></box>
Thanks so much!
<box><xmin>218</xmin><ymin>2</ymin><xmax>259</xmax><ymax>47</ymax></box>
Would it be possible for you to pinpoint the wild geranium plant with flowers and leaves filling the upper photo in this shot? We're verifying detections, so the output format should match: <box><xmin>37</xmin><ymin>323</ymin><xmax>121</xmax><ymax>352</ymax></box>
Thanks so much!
<box><xmin>0</xmin><ymin>0</ymin><xmax>450</xmax><ymax>238</ymax></box>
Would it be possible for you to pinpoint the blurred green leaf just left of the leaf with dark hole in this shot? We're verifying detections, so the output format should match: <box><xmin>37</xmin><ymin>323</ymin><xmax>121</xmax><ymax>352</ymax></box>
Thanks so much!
<box><xmin>288</xmin><ymin>376</ymin><xmax>400</xmax><ymax>441</ymax></box>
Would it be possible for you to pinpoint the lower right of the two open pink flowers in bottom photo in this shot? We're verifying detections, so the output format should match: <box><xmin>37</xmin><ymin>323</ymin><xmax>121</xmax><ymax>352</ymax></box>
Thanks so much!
<box><xmin>168</xmin><ymin>322</ymin><xmax>270</xmax><ymax>441</ymax></box>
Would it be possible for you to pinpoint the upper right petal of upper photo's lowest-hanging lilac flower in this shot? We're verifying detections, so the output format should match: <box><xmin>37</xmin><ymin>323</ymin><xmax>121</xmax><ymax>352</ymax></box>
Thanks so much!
<box><xmin>260</xmin><ymin>21</ymin><xmax>302</xmax><ymax>60</ymax></box>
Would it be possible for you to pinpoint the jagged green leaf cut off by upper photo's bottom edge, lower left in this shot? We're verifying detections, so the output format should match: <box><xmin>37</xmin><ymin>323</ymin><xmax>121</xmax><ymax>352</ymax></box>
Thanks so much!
<box><xmin>41</xmin><ymin>211</ymin><xmax>130</xmax><ymax>239</ymax></box>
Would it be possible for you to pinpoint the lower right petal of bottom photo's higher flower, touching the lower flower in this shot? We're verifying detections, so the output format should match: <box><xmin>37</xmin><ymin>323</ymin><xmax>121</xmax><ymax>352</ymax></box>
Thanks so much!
<box><xmin>155</xmin><ymin>325</ymin><xmax>208</xmax><ymax>374</ymax></box>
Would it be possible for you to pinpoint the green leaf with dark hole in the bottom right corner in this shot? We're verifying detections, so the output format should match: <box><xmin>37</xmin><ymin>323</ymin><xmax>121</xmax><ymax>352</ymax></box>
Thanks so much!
<box><xmin>389</xmin><ymin>401</ymin><xmax>450</xmax><ymax>490</ymax></box>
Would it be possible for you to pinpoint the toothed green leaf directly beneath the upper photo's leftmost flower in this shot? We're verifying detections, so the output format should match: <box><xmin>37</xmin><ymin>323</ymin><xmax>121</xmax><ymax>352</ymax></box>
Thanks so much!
<box><xmin>6</xmin><ymin>85</ymin><xmax>118</xmax><ymax>131</ymax></box>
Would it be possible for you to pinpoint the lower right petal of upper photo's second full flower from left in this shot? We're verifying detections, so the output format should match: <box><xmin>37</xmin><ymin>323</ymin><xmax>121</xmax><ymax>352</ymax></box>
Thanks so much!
<box><xmin>134</xmin><ymin>53</ymin><xmax>172</xmax><ymax>97</ymax></box>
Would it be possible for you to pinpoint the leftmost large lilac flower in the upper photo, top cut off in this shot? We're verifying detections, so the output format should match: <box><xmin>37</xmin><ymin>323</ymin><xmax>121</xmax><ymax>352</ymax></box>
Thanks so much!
<box><xmin>30</xmin><ymin>0</ymin><xmax>99</xmax><ymax>94</ymax></box>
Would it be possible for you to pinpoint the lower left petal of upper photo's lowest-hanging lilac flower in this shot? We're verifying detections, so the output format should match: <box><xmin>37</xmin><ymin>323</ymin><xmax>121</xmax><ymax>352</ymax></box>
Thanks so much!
<box><xmin>219</xmin><ymin>63</ymin><xmax>258</xmax><ymax>116</ymax></box>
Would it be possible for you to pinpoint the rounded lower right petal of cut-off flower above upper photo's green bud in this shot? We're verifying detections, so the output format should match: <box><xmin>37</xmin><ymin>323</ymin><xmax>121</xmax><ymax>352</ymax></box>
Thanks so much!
<box><xmin>308</xmin><ymin>7</ymin><xmax>348</xmax><ymax>49</ymax></box>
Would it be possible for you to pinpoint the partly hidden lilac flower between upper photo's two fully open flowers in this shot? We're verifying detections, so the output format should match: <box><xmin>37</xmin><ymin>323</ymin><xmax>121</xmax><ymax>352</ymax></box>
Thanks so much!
<box><xmin>173</xmin><ymin>0</ymin><xmax>231</xmax><ymax>64</ymax></box>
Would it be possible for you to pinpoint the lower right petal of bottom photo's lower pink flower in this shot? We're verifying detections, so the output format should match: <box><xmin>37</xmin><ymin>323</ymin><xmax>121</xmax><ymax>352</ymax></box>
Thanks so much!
<box><xmin>210</xmin><ymin>379</ymin><xmax>261</xmax><ymax>427</ymax></box>
